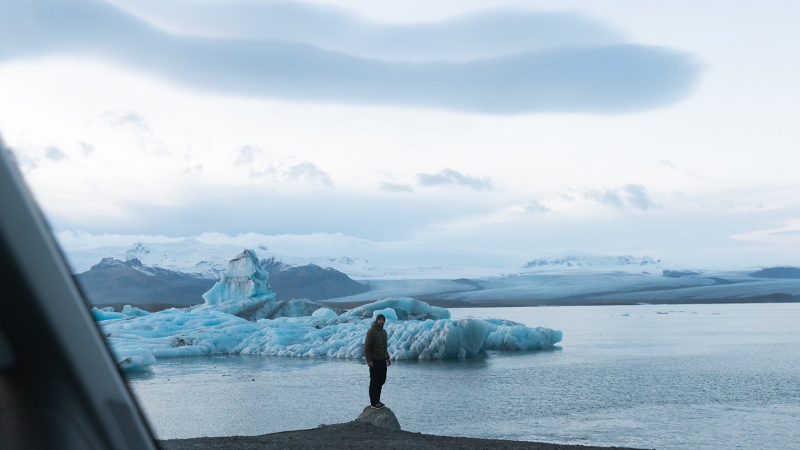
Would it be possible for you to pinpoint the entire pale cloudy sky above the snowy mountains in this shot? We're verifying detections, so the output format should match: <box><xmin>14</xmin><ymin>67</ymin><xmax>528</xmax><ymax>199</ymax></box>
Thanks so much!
<box><xmin>0</xmin><ymin>0</ymin><xmax>800</xmax><ymax>268</ymax></box>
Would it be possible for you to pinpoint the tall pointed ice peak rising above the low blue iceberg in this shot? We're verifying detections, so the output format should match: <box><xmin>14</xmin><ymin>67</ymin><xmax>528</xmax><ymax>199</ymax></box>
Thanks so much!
<box><xmin>196</xmin><ymin>250</ymin><xmax>275</xmax><ymax>314</ymax></box>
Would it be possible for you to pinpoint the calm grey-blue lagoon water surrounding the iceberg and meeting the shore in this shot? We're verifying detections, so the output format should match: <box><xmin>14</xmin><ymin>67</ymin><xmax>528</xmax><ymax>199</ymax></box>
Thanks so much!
<box><xmin>125</xmin><ymin>304</ymin><xmax>800</xmax><ymax>449</ymax></box>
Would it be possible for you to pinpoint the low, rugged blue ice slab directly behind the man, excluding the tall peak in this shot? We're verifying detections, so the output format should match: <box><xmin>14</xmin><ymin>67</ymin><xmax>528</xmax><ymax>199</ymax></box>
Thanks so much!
<box><xmin>103</xmin><ymin>309</ymin><xmax>561</xmax><ymax>360</ymax></box>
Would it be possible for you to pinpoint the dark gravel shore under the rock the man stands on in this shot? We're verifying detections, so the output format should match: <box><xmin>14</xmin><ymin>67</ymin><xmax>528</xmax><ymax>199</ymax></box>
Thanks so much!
<box><xmin>159</xmin><ymin>422</ymin><xmax>648</xmax><ymax>450</ymax></box>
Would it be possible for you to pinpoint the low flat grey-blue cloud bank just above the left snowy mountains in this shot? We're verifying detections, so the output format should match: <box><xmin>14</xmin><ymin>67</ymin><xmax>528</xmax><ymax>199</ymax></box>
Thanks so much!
<box><xmin>43</xmin><ymin>185</ymin><xmax>496</xmax><ymax>243</ymax></box>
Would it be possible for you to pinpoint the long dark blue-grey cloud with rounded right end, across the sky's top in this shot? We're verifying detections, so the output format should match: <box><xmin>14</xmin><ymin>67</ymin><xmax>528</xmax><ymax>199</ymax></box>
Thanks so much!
<box><xmin>0</xmin><ymin>0</ymin><xmax>699</xmax><ymax>114</ymax></box>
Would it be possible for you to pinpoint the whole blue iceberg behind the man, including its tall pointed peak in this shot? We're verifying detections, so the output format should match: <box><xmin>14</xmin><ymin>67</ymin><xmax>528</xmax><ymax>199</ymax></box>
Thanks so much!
<box><xmin>93</xmin><ymin>250</ymin><xmax>562</xmax><ymax>370</ymax></box>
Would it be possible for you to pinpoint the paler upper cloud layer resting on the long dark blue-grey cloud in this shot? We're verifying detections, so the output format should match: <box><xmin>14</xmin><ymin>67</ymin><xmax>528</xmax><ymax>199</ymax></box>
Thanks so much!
<box><xmin>106</xmin><ymin>0</ymin><xmax>624</xmax><ymax>61</ymax></box>
